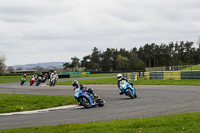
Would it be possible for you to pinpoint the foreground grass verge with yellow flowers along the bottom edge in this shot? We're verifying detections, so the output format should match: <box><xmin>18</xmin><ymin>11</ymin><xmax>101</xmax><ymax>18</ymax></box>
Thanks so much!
<box><xmin>0</xmin><ymin>112</ymin><xmax>200</xmax><ymax>133</ymax></box>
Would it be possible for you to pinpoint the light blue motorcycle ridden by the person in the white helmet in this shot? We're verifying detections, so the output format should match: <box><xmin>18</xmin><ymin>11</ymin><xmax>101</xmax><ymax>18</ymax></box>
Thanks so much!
<box><xmin>120</xmin><ymin>80</ymin><xmax>137</xmax><ymax>99</ymax></box>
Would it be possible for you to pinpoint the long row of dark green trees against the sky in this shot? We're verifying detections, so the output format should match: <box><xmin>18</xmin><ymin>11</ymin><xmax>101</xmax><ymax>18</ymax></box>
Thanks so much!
<box><xmin>63</xmin><ymin>41</ymin><xmax>200</xmax><ymax>72</ymax></box>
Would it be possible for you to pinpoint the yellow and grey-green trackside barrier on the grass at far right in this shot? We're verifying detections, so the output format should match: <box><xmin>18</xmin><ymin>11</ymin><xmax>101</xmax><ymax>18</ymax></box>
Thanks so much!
<box><xmin>144</xmin><ymin>71</ymin><xmax>200</xmax><ymax>80</ymax></box>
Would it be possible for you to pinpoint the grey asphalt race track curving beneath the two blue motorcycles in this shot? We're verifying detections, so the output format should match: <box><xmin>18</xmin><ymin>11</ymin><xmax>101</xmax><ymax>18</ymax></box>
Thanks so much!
<box><xmin>0</xmin><ymin>82</ymin><xmax>200</xmax><ymax>129</ymax></box>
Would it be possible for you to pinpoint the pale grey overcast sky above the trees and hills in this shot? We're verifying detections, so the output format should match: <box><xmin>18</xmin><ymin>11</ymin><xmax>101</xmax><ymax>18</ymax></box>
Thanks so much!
<box><xmin>0</xmin><ymin>0</ymin><xmax>200</xmax><ymax>66</ymax></box>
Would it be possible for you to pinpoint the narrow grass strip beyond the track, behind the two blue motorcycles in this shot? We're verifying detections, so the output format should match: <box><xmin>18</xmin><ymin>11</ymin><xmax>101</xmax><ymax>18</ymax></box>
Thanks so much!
<box><xmin>56</xmin><ymin>78</ymin><xmax>200</xmax><ymax>85</ymax></box>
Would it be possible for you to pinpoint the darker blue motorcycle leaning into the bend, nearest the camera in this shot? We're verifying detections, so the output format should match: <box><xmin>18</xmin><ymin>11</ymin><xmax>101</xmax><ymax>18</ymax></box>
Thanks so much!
<box><xmin>74</xmin><ymin>88</ymin><xmax>105</xmax><ymax>108</ymax></box>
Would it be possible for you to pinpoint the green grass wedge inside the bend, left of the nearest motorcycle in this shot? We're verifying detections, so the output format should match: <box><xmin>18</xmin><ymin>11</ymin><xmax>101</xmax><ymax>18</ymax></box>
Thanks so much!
<box><xmin>0</xmin><ymin>94</ymin><xmax>77</xmax><ymax>113</ymax></box>
